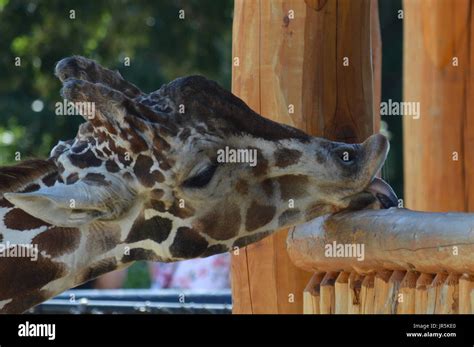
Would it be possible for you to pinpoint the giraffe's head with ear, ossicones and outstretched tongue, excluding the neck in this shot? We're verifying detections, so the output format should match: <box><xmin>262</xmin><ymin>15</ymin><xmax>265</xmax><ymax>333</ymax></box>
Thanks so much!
<box><xmin>5</xmin><ymin>57</ymin><xmax>396</xmax><ymax>260</ymax></box>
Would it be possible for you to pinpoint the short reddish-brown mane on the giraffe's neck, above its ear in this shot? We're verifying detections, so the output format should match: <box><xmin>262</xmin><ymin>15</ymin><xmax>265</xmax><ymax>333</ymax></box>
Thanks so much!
<box><xmin>0</xmin><ymin>159</ymin><xmax>58</xmax><ymax>197</ymax></box>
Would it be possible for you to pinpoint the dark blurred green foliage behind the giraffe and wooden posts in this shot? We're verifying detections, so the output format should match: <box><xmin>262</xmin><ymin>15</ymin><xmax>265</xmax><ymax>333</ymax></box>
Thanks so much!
<box><xmin>0</xmin><ymin>0</ymin><xmax>403</xmax><ymax>288</ymax></box>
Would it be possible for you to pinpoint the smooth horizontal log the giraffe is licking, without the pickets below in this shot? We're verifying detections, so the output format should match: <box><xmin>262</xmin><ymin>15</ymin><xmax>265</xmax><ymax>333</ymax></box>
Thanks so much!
<box><xmin>287</xmin><ymin>208</ymin><xmax>474</xmax><ymax>273</ymax></box>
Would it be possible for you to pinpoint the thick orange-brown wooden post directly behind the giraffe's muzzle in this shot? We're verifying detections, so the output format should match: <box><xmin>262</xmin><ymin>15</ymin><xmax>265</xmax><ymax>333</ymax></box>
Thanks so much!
<box><xmin>232</xmin><ymin>0</ymin><xmax>380</xmax><ymax>313</ymax></box>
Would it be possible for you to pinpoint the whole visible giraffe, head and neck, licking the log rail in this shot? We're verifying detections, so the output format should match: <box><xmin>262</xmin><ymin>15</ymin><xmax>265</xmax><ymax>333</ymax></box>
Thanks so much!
<box><xmin>0</xmin><ymin>56</ymin><xmax>397</xmax><ymax>312</ymax></box>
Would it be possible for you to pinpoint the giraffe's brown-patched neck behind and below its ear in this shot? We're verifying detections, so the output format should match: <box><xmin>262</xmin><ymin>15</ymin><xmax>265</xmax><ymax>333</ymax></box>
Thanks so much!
<box><xmin>0</xmin><ymin>162</ymin><xmax>152</xmax><ymax>313</ymax></box>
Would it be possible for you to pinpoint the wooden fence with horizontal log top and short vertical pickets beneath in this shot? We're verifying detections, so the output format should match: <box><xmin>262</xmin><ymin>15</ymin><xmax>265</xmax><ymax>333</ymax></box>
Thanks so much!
<box><xmin>287</xmin><ymin>209</ymin><xmax>474</xmax><ymax>314</ymax></box>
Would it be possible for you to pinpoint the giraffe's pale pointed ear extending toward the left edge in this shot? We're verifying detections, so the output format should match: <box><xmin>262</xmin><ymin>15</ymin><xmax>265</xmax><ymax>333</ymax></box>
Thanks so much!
<box><xmin>4</xmin><ymin>181</ymin><xmax>135</xmax><ymax>227</ymax></box>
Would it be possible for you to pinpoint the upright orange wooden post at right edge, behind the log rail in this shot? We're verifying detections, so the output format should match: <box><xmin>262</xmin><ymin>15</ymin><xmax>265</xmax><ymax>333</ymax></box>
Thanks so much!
<box><xmin>403</xmin><ymin>0</ymin><xmax>474</xmax><ymax>211</ymax></box>
